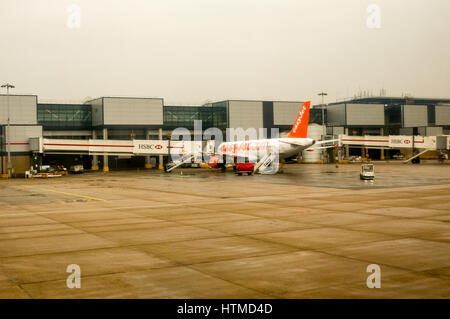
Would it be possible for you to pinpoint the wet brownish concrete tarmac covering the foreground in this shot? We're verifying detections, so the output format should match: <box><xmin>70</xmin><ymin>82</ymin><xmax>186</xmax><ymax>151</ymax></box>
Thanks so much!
<box><xmin>0</xmin><ymin>163</ymin><xmax>450</xmax><ymax>298</ymax></box>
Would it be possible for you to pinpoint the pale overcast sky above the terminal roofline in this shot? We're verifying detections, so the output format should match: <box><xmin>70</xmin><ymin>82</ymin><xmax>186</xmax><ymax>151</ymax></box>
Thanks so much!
<box><xmin>0</xmin><ymin>0</ymin><xmax>450</xmax><ymax>105</ymax></box>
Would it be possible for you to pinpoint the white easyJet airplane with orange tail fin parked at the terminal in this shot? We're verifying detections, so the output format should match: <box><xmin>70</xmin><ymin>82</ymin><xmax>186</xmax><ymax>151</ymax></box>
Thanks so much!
<box><xmin>166</xmin><ymin>101</ymin><xmax>335</xmax><ymax>174</ymax></box>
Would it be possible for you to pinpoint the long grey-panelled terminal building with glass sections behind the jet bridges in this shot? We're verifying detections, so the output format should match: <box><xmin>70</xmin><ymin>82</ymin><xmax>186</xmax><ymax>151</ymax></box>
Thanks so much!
<box><xmin>0</xmin><ymin>95</ymin><xmax>450</xmax><ymax>174</ymax></box>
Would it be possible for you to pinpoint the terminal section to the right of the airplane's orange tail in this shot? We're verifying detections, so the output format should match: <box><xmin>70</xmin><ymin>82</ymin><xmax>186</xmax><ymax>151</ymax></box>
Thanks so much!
<box><xmin>324</xmin><ymin>97</ymin><xmax>450</xmax><ymax>158</ymax></box>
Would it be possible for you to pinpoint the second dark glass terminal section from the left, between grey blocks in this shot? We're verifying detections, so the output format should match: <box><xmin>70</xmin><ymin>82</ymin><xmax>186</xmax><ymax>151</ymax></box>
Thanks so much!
<box><xmin>164</xmin><ymin>106</ymin><xmax>228</xmax><ymax>130</ymax></box>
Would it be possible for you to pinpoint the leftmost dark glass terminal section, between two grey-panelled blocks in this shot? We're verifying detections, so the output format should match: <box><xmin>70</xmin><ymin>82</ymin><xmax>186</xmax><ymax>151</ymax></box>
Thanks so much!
<box><xmin>37</xmin><ymin>104</ymin><xmax>92</xmax><ymax>130</ymax></box>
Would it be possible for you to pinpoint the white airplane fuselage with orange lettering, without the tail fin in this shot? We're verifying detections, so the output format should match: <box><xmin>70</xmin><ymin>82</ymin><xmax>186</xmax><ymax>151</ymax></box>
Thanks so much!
<box><xmin>217</xmin><ymin>138</ymin><xmax>316</xmax><ymax>159</ymax></box>
